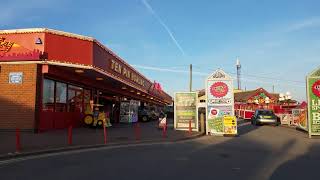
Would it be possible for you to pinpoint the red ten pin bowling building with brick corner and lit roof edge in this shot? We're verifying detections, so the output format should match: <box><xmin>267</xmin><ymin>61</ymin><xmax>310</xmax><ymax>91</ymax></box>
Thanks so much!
<box><xmin>0</xmin><ymin>29</ymin><xmax>172</xmax><ymax>130</ymax></box>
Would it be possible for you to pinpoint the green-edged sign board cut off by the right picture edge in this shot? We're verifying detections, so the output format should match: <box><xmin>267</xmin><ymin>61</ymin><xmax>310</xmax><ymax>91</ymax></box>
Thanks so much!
<box><xmin>307</xmin><ymin>68</ymin><xmax>320</xmax><ymax>137</ymax></box>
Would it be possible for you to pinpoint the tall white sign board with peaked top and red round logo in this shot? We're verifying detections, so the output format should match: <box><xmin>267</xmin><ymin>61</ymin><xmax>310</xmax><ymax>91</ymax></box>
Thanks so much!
<box><xmin>206</xmin><ymin>69</ymin><xmax>234</xmax><ymax>135</ymax></box>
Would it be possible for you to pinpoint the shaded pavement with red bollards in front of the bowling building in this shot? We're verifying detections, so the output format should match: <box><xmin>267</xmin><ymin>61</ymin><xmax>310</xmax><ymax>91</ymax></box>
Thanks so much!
<box><xmin>0</xmin><ymin>120</ymin><xmax>201</xmax><ymax>159</ymax></box>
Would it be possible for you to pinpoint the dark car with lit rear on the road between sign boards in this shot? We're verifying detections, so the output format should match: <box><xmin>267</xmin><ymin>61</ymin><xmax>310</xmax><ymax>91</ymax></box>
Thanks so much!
<box><xmin>251</xmin><ymin>109</ymin><xmax>280</xmax><ymax>126</ymax></box>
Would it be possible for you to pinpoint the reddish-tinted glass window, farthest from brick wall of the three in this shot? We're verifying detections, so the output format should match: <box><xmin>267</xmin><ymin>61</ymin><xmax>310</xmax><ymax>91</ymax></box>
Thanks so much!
<box><xmin>68</xmin><ymin>85</ymin><xmax>83</xmax><ymax>112</ymax></box>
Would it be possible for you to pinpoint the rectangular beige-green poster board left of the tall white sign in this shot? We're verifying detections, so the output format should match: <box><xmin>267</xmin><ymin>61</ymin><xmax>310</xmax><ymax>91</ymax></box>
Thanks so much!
<box><xmin>174</xmin><ymin>92</ymin><xmax>198</xmax><ymax>131</ymax></box>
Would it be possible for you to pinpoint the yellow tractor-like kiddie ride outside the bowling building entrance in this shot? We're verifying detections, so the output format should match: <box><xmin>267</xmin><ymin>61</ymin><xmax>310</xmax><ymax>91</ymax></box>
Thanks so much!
<box><xmin>83</xmin><ymin>104</ymin><xmax>112</xmax><ymax>128</ymax></box>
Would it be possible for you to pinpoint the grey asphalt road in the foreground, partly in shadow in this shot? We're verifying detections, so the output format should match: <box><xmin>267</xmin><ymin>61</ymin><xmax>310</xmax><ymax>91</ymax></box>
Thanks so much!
<box><xmin>0</xmin><ymin>125</ymin><xmax>320</xmax><ymax>180</ymax></box>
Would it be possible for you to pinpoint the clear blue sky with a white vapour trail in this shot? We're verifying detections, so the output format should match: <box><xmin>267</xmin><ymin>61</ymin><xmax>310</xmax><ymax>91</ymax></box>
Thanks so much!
<box><xmin>0</xmin><ymin>0</ymin><xmax>320</xmax><ymax>100</ymax></box>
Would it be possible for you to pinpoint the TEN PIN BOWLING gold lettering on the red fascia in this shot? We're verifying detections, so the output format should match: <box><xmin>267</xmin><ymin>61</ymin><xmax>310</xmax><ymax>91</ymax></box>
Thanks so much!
<box><xmin>111</xmin><ymin>59</ymin><xmax>145</xmax><ymax>86</ymax></box>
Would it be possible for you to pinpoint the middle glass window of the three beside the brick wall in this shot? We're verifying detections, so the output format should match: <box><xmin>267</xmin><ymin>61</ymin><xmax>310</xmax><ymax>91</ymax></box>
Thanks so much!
<box><xmin>56</xmin><ymin>82</ymin><xmax>67</xmax><ymax>112</ymax></box>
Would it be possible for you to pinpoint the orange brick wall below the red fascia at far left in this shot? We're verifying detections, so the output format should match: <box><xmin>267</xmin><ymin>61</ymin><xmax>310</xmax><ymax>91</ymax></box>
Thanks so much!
<box><xmin>0</xmin><ymin>64</ymin><xmax>37</xmax><ymax>129</ymax></box>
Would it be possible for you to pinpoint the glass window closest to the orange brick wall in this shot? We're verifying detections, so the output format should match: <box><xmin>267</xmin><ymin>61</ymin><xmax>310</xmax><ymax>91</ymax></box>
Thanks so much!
<box><xmin>42</xmin><ymin>79</ymin><xmax>54</xmax><ymax>112</ymax></box>
